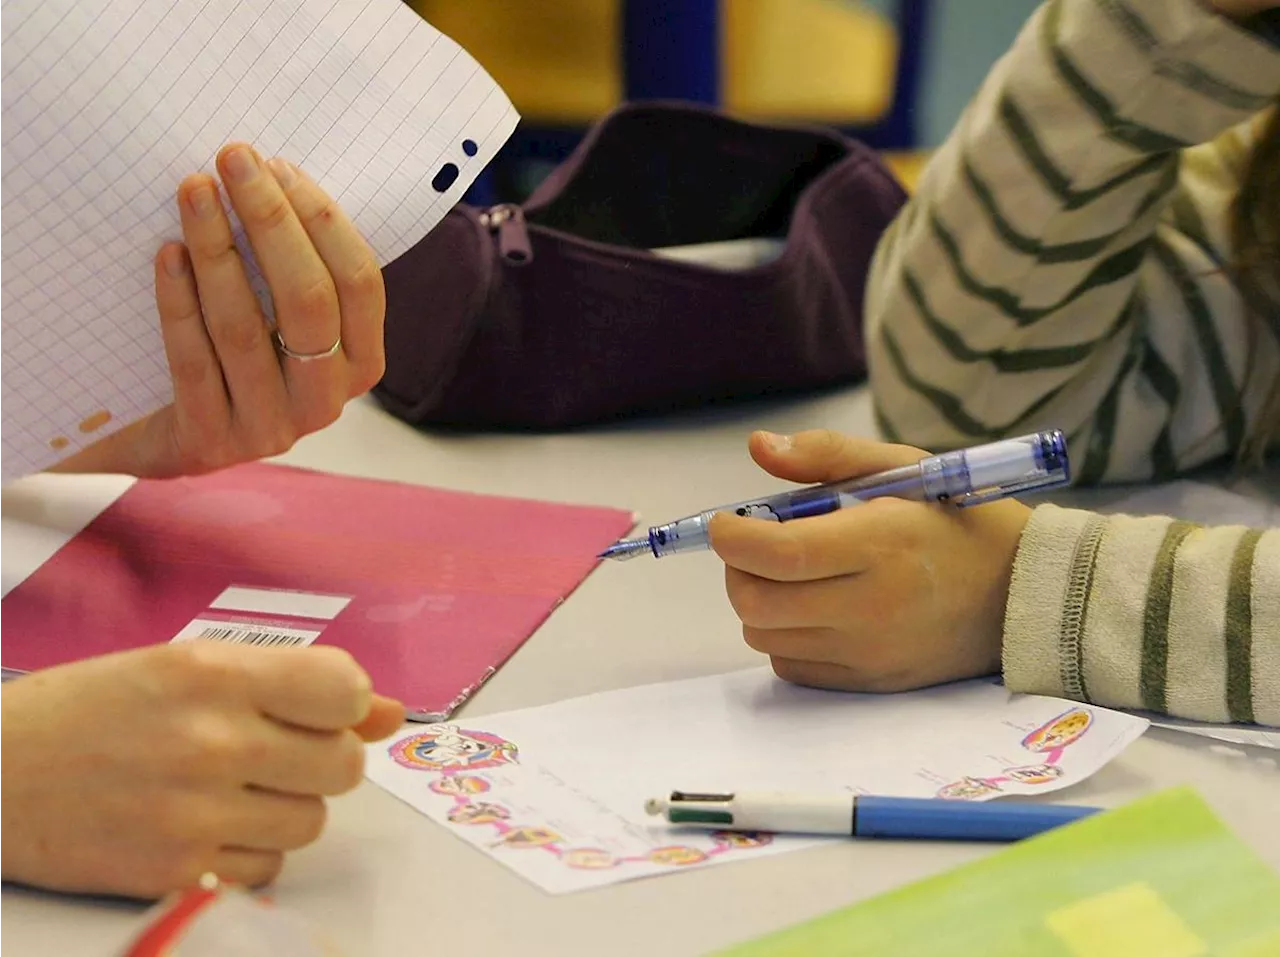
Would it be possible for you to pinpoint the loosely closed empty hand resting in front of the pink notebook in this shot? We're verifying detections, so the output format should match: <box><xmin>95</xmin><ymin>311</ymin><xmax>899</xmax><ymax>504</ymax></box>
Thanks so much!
<box><xmin>0</xmin><ymin>641</ymin><xmax>404</xmax><ymax>898</ymax></box>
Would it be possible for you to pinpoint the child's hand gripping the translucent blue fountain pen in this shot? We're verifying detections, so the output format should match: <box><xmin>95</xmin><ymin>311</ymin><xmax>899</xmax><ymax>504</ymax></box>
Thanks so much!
<box><xmin>710</xmin><ymin>431</ymin><xmax>1030</xmax><ymax>692</ymax></box>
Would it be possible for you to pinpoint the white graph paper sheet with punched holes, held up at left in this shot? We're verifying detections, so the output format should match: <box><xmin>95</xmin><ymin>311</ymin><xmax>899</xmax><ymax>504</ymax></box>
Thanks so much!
<box><xmin>0</xmin><ymin>0</ymin><xmax>517</xmax><ymax>480</ymax></box>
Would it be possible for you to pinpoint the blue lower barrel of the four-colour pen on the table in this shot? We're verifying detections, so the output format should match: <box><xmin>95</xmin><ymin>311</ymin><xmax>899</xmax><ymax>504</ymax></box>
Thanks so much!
<box><xmin>854</xmin><ymin>797</ymin><xmax>1098</xmax><ymax>842</ymax></box>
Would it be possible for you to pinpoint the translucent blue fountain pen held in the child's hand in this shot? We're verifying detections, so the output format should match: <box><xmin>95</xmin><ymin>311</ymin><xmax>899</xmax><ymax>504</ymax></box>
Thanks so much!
<box><xmin>600</xmin><ymin>429</ymin><xmax>1071</xmax><ymax>560</ymax></box>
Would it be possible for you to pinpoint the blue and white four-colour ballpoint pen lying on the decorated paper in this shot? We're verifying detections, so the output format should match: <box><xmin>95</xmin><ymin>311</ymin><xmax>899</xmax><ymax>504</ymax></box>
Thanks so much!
<box><xmin>645</xmin><ymin>791</ymin><xmax>1101</xmax><ymax>842</ymax></box>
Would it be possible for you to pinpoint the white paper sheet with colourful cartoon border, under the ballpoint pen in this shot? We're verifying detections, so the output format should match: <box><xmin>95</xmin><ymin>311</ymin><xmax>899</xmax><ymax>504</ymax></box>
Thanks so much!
<box><xmin>366</xmin><ymin>669</ymin><xmax>1147</xmax><ymax>893</ymax></box>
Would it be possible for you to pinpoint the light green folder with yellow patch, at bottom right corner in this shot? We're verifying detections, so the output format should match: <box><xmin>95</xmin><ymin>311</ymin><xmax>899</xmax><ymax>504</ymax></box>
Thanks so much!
<box><xmin>721</xmin><ymin>788</ymin><xmax>1280</xmax><ymax>957</ymax></box>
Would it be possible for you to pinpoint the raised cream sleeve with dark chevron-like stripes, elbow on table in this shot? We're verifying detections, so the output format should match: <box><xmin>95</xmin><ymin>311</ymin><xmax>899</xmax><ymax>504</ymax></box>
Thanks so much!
<box><xmin>867</xmin><ymin>0</ymin><xmax>1280</xmax><ymax>458</ymax></box>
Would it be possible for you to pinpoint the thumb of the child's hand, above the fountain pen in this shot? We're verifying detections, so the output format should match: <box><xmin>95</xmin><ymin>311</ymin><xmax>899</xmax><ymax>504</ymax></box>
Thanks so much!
<box><xmin>748</xmin><ymin>429</ymin><xmax>928</xmax><ymax>484</ymax></box>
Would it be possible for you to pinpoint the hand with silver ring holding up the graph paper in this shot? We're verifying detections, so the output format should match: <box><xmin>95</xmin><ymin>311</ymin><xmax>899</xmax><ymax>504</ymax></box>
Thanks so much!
<box><xmin>58</xmin><ymin>145</ymin><xmax>385</xmax><ymax>477</ymax></box>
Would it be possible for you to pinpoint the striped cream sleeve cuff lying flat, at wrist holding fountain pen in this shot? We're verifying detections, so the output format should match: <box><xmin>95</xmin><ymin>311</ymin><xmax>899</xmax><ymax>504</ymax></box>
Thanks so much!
<box><xmin>1004</xmin><ymin>505</ymin><xmax>1280</xmax><ymax>725</ymax></box>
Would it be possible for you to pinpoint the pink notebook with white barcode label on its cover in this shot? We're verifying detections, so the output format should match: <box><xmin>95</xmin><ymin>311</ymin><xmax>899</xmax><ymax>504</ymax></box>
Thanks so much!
<box><xmin>0</xmin><ymin>464</ymin><xmax>634</xmax><ymax>718</ymax></box>
